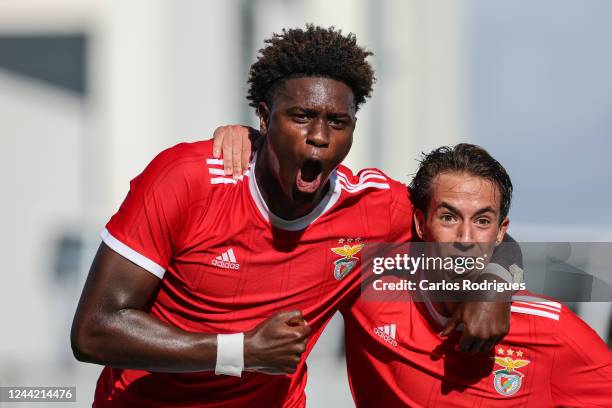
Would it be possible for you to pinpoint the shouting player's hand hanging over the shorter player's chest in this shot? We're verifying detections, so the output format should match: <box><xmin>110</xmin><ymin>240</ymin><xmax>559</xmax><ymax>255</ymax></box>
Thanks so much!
<box><xmin>440</xmin><ymin>302</ymin><xmax>510</xmax><ymax>353</ymax></box>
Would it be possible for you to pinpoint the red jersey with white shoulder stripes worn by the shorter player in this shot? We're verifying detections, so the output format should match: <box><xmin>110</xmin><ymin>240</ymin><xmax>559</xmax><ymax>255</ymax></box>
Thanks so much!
<box><xmin>343</xmin><ymin>278</ymin><xmax>612</xmax><ymax>407</ymax></box>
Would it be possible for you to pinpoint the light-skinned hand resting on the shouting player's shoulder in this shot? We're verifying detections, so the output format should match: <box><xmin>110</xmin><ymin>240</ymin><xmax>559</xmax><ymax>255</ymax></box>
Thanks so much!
<box><xmin>213</xmin><ymin>125</ymin><xmax>261</xmax><ymax>179</ymax></box>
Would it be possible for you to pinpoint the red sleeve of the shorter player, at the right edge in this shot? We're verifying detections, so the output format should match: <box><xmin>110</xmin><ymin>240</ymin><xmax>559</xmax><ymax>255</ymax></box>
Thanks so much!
<box><xmin>550</xmin><ymin>307</ymin><xmax>612</xmax><ymax>407</ymax></box>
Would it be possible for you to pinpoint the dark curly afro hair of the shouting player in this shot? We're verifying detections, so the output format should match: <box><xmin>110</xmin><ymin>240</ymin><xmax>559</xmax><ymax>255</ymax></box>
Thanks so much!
<box><xmin>247</xmin><ymin>24</ymin><xmax>376</xmax><ymax>109</ymax></box>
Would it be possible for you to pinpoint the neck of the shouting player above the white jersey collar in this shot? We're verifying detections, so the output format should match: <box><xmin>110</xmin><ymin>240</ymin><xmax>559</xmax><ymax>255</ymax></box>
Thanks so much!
<box><xmin>255</xmin><ymin>146</ymin><xmax>329</xmax><ymax>220</ymax></box>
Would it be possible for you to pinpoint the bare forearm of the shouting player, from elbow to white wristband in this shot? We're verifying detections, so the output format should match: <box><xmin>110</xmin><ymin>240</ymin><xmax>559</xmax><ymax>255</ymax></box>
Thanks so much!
<box><xmin>72</xmin><ymin>309</ymin><xmax>217</xmax><ymax>372</ymax></box>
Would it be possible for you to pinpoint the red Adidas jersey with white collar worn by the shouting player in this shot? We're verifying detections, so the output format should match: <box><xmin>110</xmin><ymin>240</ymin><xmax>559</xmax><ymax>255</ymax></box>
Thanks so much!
<box><xmin>94</xmin><ymin>141</ymin><xmax>412</xmax><ymax>407</ymax></box>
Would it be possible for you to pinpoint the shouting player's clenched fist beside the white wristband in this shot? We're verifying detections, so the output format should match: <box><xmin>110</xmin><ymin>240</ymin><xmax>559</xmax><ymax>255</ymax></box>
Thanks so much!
<box><xmin>244</xmin><ymin>310</ymin><xmax>312</xmax><ymax>374</ymax></box>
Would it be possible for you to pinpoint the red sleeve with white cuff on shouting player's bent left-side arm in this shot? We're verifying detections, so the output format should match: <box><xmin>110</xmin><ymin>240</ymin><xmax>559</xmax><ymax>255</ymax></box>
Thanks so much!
<box><xmin>101</xmin><ymin>143</ymin><xmax>208</xmax><ymax>278</ymax></box>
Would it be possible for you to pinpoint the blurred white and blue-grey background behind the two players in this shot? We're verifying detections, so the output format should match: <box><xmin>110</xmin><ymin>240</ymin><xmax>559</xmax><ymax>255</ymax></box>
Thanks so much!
<box><xmin>0</xmin><ymin>0</ymin><xmax>612</xmax><ymax>407</ymax></box>
